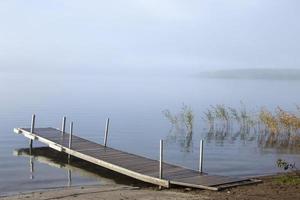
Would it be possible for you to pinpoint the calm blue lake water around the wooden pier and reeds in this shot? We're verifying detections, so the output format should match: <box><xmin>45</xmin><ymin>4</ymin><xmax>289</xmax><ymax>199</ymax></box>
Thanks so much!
<box><xmin>0</xmin><ymin>73</ymin><xmax>300</xmax><ymax>195</ymax></box>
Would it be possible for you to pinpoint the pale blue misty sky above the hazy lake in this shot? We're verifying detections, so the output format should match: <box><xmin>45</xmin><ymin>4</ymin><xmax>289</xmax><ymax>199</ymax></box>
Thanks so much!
<box><xmin>0</xmin><ymin>0</ymin><xmax>300</xmax><ymax>72</ymax></box>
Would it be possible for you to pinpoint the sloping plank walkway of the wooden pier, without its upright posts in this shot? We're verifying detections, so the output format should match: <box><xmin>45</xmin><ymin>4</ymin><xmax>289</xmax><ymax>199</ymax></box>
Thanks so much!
<box><xmin>14</xmin><ymin>128</ymin><xmax>259</xmax><ymax>190</ymax></box>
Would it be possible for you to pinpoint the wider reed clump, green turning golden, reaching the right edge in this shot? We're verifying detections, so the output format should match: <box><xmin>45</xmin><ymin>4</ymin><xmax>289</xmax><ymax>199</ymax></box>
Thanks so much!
<box><xmin>204</xmin><ymin>103</ymin><xmax>300</xmax><ymax>148</ymax></box>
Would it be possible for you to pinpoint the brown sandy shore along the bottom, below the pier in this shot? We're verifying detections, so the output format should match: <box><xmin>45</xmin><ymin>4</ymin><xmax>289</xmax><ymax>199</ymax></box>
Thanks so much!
<box><xmin>0</xmin><ymin>176</ymin><xmax>300</xmax><ymax>200</ymax></box>
